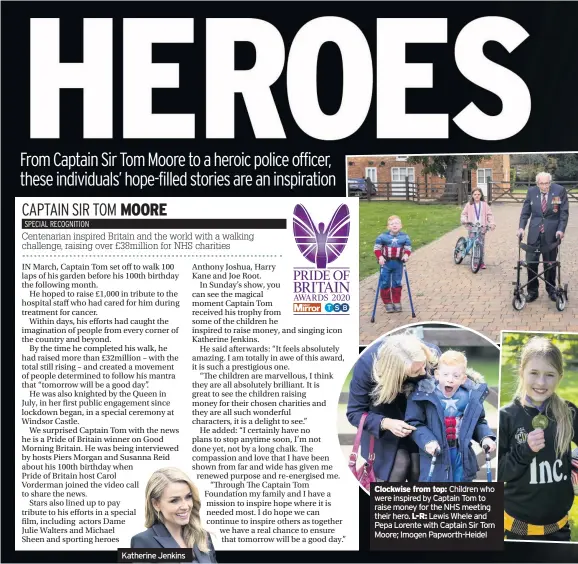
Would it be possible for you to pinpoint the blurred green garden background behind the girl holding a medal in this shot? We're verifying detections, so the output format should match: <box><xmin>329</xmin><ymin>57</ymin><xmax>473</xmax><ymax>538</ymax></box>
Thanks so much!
<box><xmin>500</xmin><ymin>332</ymin><xmax>578</xmax><ymax>542</ymax></box>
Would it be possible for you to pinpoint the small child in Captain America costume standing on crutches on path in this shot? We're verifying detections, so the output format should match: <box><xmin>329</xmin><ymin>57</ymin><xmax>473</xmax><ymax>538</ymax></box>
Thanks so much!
<box><xmin>373</xmin><ymin>215</ymin><xmax>411</xmax><ymax>313</ymax></box>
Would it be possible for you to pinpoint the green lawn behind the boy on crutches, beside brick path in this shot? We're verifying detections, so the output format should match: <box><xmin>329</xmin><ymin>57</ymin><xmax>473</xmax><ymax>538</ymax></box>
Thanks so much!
<box><xmin>359</xmin><ymin>201</ymin><xmax>462</xmax><ymax>279</ymax></box>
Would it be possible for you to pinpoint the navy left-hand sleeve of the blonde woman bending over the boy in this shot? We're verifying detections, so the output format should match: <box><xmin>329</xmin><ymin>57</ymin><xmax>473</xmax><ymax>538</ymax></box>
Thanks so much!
<box><xmin>346</xmin><ymin>357</ymin><xmax>391</xmax><ymax>438</ymax></box>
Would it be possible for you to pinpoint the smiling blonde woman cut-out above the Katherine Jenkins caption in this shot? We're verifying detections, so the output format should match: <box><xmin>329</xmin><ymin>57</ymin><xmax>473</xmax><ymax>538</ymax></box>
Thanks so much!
<box><xmin>130</xmin><ymin>468</ymin><xmax>217</xmax><ymax>563</ymax></box>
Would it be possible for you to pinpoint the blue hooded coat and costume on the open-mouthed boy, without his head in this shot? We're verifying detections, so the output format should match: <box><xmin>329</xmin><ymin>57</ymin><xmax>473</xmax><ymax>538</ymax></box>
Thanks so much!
<box><xmin>405</xmin><ymin>370</ymin><xmax>496</xmax><ymax>482</ymax></box>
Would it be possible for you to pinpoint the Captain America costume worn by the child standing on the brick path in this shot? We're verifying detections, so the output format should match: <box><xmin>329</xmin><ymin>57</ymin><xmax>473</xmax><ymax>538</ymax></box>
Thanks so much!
<box><xmin>373</xmin><ymin>231</ymin><xmax>411</xmax><ymax>305</ymax></box>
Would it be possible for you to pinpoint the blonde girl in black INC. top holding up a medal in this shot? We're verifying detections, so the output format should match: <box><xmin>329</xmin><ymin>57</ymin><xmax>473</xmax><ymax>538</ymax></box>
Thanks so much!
<box><xmin>498</xmin><ymin>337</ymin><xmax>578</xmax><ymax>541</ymax></box>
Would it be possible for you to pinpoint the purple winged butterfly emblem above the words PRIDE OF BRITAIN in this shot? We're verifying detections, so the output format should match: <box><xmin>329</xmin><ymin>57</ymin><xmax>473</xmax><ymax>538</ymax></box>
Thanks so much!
<box><xmin>293</xmin><ymin>204</ymin><xmax>349</xmax><ymax>268</ymax></box>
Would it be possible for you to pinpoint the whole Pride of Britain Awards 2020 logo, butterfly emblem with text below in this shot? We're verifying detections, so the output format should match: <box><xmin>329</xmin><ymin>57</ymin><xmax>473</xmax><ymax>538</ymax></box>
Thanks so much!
<box><xmin>293</xmin><ymin>204</ymin><xmax>350</xmax><ymax>315</ymax></box>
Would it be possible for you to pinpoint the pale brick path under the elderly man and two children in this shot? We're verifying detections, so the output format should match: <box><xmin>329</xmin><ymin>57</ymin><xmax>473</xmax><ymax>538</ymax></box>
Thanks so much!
<box><xmin>359</xmin><ymin>203</ymin><xmax>578</xmax><ymax>345</ymax></box>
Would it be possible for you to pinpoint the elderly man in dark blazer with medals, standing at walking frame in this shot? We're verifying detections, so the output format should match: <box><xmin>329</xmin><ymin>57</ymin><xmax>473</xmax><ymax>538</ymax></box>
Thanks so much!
<box><xmin>518</xmin><ymin>172</ymin><xmax>569</xmax><ymax>302</ymax></box>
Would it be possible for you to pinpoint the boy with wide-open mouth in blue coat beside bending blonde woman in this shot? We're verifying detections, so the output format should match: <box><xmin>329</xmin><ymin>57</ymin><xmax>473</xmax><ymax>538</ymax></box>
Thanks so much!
<box><xmin>405</xmin><ymin>350</ymin><xmax>496</xmax><ymax>482</ymax></box>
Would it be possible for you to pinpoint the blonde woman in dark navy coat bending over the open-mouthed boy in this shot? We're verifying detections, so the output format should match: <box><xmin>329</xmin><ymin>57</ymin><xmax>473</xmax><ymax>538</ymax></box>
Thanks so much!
<box><xmin>347</xmin><ymin>333</ymin><xmax>440</xmax><ymax>482</ymax></box>
